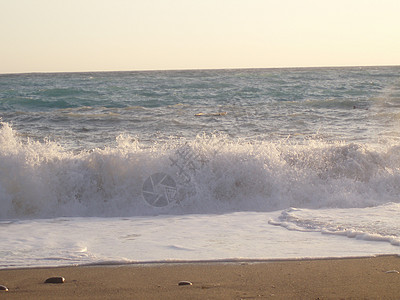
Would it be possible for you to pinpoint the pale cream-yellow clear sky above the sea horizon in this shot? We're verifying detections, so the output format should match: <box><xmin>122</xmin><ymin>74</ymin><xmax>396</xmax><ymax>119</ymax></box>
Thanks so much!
<box><xmin>0</xmin><ymin>0</ymin><xmax>400</xmax><ymax>73</ymax></box>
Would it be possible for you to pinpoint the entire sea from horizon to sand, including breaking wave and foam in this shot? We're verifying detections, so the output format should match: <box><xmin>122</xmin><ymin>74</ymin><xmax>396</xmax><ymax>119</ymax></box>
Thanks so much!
<box><xmin>0</xmin><ymin>67</ymin><xmax>400</xmax><ymax>268</ymax></box>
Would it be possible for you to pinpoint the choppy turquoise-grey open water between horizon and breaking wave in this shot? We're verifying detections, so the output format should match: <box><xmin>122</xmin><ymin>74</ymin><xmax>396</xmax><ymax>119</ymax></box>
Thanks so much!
<box><xmin>0</xmin><ymin>67</ymin><xmax>400</xmax><ymax>149</ymax></box>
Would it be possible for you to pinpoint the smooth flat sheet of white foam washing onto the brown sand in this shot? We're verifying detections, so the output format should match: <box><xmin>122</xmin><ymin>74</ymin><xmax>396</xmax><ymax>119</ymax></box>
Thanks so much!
<box><xmin>0</xmin><ymin>212</ymin><xmax>400</xmax><ymax>268</ymax></box>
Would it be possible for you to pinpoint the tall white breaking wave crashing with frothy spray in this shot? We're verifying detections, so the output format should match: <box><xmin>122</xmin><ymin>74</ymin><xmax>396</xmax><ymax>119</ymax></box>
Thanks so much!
<box><xmin>0</xmin><ymin>123</ymin><xmax>400</xmax><ymax>219</ymax></box>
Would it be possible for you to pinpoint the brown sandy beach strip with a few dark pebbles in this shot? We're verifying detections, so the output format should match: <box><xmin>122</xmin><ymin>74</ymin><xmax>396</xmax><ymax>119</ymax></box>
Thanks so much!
<box><xmin>0</xmin><ymin>256</ymin><xmax>400</xmax><ymax>299</ymax></box>
